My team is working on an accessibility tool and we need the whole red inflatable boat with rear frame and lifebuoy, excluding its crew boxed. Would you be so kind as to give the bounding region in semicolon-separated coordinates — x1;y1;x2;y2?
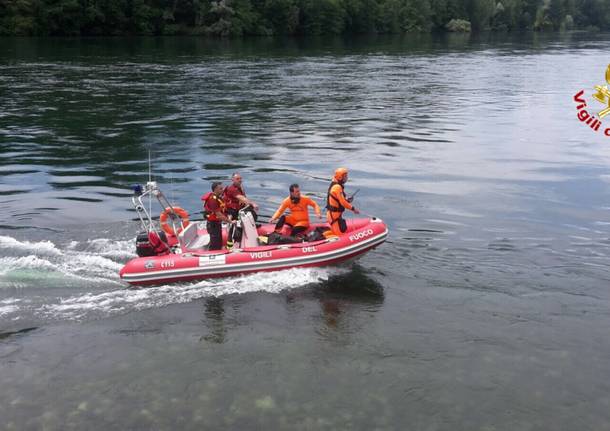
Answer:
120;183;388;285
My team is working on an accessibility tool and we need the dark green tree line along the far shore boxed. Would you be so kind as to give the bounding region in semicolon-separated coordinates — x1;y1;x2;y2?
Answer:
0;0;610;37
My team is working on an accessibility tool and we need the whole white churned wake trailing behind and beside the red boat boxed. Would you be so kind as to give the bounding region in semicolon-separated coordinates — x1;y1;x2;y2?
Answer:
0;236;332;321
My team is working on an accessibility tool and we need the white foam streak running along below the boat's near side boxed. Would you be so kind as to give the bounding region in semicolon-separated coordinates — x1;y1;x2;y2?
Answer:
39;268;330;320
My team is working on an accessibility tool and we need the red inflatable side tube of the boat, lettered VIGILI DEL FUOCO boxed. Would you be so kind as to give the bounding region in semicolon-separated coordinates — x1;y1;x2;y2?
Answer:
120;219;388;285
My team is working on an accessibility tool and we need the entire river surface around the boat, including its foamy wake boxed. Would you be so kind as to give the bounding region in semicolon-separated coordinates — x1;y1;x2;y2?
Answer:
0;33;610;431
